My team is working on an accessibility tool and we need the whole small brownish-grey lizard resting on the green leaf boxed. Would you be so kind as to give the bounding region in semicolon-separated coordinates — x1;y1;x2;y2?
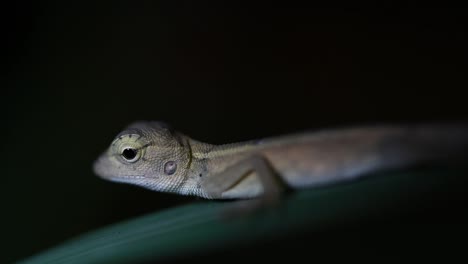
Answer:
93;121;468;204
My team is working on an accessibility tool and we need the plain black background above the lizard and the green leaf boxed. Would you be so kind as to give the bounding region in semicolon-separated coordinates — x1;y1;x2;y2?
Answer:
0;1;468;263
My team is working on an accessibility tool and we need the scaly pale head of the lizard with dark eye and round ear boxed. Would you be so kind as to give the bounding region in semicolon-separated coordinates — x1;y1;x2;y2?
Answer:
94;122;192;192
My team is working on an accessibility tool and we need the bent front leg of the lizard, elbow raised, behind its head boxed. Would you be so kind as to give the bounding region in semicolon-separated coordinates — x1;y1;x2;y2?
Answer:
201;154;286;204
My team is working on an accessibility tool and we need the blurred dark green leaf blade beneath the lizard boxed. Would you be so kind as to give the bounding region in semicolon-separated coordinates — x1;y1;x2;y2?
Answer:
17;170;466;263
